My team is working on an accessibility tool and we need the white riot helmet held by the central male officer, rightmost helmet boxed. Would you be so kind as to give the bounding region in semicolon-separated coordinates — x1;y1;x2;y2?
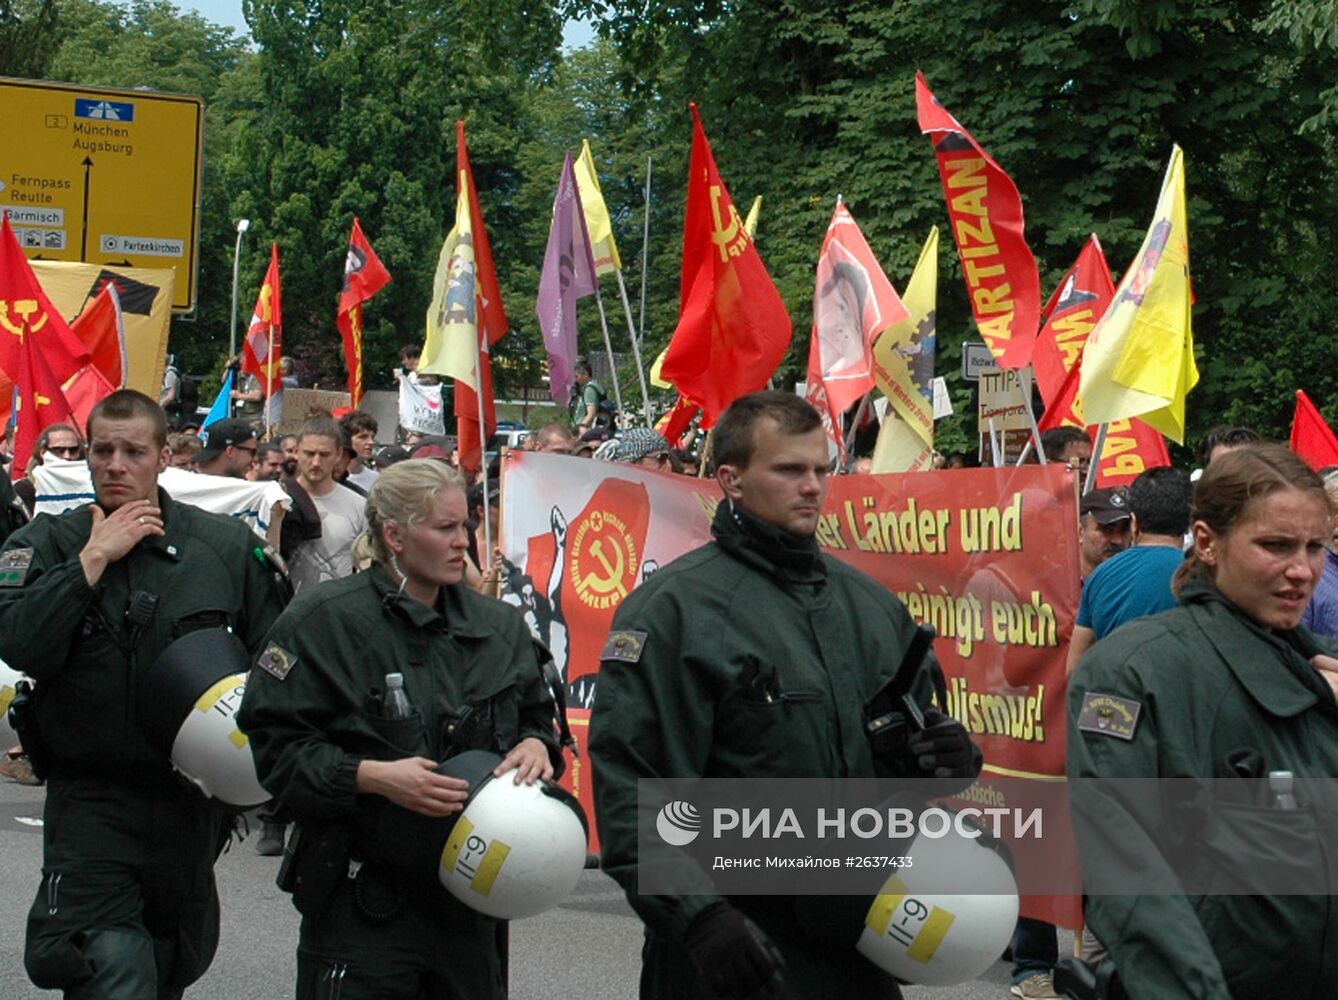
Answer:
855;825;1018;987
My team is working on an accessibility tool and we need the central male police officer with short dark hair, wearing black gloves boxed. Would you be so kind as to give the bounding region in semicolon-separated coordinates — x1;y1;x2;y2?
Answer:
590;392;981;1000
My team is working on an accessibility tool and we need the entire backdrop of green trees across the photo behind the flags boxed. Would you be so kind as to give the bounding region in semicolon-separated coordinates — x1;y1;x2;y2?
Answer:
10;0;1338;448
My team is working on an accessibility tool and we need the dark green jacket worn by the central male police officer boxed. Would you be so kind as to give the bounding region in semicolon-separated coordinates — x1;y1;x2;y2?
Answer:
590;503;914;968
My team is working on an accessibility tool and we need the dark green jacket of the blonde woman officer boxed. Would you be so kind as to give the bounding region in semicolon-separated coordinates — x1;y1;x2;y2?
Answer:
238;566;561;825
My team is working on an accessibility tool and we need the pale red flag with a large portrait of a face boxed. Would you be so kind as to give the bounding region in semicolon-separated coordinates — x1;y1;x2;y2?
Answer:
807;202;910;448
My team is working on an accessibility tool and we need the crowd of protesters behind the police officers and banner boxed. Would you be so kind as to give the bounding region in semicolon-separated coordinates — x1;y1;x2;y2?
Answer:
0;350;1338;1000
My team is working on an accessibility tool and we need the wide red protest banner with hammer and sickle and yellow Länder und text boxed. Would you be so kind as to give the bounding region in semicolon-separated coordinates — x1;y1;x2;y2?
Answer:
500;451;1078;926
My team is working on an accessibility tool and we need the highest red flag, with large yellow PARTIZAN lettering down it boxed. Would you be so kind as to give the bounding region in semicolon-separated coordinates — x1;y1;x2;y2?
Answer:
915;72;1041;368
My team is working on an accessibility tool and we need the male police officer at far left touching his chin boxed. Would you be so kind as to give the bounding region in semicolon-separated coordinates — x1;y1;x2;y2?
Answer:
0;390;282;1000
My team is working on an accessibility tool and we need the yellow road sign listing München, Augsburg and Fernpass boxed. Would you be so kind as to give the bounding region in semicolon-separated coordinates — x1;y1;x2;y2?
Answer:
0;79;205;312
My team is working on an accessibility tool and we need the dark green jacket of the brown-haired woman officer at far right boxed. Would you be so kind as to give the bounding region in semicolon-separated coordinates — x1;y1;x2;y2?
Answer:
1068;581;1338;1000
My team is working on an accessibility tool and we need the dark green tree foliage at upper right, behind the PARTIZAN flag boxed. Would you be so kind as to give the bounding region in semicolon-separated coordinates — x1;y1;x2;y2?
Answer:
574;0;1338;449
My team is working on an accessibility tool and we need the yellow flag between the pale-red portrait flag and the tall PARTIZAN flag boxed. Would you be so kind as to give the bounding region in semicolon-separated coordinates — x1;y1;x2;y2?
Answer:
874;226;938;473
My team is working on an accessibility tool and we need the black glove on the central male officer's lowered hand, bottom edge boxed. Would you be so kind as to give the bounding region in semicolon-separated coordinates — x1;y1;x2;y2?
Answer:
684;902;785;1000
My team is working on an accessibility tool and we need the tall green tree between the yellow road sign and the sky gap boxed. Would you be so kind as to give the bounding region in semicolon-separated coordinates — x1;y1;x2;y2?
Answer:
229;0;561;396
